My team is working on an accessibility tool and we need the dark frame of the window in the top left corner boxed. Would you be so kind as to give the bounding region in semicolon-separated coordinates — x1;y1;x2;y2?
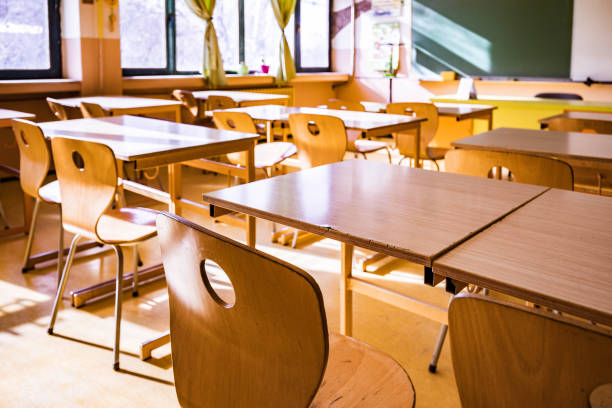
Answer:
0;0;62;80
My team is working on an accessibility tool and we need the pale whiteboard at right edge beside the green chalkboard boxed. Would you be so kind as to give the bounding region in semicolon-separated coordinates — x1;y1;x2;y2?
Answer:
570;0;612;81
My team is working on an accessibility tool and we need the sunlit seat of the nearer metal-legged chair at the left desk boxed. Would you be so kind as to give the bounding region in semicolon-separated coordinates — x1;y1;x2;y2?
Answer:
97;208;157;244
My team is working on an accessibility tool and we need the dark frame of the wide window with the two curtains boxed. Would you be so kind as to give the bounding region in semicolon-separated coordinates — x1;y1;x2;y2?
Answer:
123;0;333;77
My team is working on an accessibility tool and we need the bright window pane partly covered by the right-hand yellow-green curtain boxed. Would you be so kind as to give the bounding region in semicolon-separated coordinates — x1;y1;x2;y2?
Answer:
244;0;295;75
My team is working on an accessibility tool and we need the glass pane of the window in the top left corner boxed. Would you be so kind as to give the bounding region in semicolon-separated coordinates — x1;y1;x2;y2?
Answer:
0;0;51;70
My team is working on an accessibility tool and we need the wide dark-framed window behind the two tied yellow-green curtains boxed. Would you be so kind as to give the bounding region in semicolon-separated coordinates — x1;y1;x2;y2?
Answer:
120;0;331;76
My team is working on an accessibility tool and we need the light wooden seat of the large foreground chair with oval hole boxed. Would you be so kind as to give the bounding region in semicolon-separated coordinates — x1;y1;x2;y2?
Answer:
310;334;414;408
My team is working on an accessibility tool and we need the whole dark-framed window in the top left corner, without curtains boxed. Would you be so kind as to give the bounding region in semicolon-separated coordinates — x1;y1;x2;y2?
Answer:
0;0;62;79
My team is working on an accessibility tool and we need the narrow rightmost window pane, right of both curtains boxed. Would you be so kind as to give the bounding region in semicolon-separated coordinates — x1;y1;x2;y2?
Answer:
300;0;329;68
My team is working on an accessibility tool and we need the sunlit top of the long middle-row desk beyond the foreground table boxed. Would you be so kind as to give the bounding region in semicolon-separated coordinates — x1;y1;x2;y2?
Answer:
216;105;427;131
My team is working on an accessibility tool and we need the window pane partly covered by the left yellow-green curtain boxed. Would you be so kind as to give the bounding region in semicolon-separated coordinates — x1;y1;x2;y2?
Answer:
176;0;239;72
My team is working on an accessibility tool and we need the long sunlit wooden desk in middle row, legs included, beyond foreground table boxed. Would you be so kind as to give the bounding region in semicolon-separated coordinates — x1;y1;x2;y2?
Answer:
218;105;426;167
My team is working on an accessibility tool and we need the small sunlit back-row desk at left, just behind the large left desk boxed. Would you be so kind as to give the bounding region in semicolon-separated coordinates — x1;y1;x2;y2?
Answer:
57;95;182;122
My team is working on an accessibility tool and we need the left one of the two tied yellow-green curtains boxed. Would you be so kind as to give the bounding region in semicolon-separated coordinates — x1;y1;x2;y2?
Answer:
185;0;226;89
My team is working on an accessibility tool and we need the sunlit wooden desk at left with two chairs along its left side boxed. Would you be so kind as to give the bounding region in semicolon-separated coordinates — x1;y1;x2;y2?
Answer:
39;116;257;306
